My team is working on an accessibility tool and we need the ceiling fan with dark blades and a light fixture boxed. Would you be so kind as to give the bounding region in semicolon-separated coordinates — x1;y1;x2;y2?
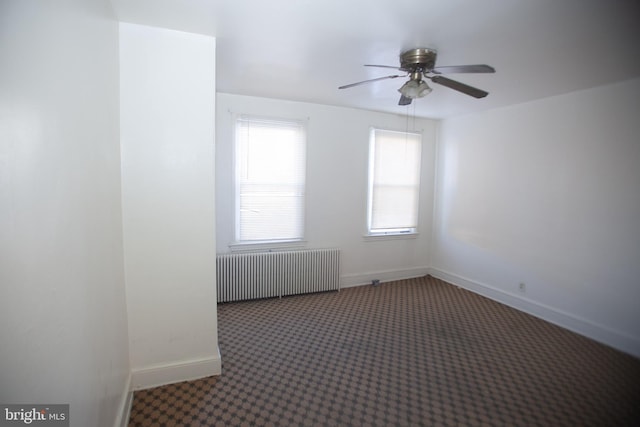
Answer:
338;48;496;105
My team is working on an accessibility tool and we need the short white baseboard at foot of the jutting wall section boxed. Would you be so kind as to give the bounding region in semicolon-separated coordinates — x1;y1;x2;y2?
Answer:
131;349;222;390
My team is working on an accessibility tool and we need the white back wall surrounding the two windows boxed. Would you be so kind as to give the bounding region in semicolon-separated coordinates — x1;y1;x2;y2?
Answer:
216;93;437;286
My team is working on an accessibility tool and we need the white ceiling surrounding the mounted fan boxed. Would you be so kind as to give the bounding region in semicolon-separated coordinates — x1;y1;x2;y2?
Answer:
112;0;640;118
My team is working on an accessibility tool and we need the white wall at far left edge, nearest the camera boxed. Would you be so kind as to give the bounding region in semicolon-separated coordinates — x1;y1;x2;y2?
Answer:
0;0;129;426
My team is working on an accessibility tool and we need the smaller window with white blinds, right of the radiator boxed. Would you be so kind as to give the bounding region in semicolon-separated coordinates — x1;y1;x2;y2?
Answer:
367;129;422;235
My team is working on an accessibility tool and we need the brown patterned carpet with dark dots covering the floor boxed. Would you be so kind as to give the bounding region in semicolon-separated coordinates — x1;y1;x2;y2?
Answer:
129;276;640;427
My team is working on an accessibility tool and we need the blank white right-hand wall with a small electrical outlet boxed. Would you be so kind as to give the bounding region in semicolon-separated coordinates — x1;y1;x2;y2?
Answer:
433;79;640;356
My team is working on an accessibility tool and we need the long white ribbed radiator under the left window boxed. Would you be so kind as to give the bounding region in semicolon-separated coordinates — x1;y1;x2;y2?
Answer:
216;249;340;302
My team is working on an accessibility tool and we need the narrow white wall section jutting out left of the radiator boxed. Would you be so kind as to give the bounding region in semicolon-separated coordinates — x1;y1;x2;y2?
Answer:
120;23;220;388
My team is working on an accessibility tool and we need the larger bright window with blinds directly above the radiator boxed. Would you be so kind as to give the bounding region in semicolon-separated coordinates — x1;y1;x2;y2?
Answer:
235;116;306;243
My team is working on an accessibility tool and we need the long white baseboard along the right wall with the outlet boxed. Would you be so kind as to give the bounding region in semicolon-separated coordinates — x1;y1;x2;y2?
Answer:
428;268;640;357
